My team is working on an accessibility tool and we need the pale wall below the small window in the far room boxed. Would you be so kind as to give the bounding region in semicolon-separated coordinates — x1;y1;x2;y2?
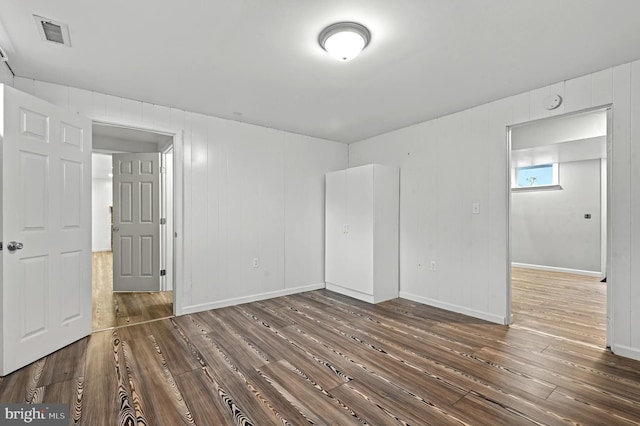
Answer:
511;159;601;273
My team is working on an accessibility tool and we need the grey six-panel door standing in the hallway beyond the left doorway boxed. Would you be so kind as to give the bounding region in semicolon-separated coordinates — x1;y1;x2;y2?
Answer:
113;152;161;291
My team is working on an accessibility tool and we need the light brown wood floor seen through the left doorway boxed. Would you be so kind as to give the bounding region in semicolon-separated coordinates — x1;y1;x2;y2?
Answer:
92;252;173;331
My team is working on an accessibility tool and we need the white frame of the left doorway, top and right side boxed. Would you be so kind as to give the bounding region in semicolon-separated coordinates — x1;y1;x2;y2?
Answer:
91;120;184;316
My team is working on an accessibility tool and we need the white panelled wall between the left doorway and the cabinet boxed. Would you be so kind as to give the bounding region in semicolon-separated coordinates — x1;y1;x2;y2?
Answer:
7;77;348;314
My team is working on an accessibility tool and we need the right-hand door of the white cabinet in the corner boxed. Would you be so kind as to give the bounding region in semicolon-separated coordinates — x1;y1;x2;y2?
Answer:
346;166;374;294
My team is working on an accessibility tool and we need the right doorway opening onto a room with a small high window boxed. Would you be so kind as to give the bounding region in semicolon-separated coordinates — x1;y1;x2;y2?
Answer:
507;107;611;347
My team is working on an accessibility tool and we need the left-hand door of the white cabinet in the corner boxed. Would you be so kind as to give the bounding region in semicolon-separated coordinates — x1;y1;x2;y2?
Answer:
324;170;348;286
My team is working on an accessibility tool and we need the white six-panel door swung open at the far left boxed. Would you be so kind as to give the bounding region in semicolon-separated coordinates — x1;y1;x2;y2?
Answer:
0;85;91;376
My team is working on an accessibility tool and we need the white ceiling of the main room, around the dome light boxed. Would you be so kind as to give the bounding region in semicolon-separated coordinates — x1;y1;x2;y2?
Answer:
0;0;640;143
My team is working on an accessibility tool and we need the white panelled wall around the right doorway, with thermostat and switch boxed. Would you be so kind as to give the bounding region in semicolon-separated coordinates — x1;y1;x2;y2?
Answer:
349;61;640;359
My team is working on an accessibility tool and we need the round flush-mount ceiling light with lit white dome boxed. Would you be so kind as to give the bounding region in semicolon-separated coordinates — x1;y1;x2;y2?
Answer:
318;22;371;61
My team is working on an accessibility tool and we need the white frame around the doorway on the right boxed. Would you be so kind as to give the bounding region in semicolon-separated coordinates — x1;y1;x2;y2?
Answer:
505;104;614;348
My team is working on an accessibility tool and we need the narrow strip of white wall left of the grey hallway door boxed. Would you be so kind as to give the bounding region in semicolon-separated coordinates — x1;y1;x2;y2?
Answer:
91;153;113;252
